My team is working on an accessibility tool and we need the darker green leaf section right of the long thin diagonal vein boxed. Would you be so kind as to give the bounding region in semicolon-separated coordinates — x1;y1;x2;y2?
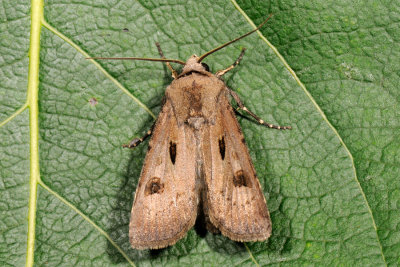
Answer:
239;0;400;266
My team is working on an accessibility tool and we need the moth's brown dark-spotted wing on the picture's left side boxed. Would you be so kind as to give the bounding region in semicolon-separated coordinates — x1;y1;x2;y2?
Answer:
129;97;198;249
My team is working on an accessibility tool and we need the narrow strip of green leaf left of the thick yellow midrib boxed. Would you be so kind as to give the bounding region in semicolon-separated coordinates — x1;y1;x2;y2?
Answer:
0;1;30;266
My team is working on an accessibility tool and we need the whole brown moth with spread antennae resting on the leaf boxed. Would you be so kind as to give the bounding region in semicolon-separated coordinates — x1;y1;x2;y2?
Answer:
93;14;291;249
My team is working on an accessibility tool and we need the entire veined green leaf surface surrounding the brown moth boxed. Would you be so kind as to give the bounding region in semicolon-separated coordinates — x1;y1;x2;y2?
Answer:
0;0;400;266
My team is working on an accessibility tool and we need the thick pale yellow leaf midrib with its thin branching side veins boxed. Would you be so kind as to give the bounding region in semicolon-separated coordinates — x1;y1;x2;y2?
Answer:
22;0;142;267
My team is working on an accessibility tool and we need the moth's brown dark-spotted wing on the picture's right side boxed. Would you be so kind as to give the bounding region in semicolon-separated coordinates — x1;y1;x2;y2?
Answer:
202;89;271;242
